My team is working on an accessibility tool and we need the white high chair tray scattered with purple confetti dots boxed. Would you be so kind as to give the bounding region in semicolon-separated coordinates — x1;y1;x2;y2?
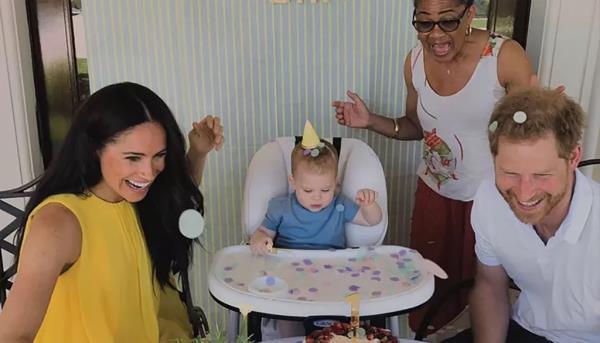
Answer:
208;246;434;317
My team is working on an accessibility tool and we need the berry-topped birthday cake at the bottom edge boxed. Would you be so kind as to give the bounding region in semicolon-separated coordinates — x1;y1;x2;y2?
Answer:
304;322;398;343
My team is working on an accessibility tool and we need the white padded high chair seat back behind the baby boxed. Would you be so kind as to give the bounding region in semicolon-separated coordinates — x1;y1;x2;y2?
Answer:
228;137;388;338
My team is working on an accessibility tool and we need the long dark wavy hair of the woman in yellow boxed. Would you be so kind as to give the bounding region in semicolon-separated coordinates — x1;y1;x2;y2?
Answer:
15;82;204;287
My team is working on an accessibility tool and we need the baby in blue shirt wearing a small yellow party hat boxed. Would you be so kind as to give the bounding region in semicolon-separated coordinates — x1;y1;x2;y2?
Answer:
250;121;382;255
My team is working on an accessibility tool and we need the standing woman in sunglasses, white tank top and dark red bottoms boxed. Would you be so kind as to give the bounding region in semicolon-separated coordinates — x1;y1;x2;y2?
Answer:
333;0;532;329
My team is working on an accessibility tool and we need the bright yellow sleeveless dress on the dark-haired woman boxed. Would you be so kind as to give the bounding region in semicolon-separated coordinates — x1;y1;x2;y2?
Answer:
25;194;160;343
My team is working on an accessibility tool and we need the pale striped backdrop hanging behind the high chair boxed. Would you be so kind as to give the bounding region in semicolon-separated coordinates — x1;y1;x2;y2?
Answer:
83;0;421;334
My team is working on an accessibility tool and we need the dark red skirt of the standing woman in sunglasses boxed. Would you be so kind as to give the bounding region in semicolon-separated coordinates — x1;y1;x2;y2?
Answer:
409;179;476;331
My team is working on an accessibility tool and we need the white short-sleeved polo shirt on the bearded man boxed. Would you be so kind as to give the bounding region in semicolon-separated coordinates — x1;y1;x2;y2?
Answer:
471;171;600;343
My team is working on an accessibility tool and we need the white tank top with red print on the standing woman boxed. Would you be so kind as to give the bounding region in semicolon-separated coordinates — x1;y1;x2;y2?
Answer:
411;34;506;201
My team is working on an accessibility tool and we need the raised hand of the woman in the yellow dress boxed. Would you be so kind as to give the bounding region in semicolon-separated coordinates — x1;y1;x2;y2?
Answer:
188;115;224;156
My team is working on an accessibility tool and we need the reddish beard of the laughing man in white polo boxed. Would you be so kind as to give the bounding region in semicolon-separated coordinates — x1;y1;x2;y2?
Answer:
500;188;567;225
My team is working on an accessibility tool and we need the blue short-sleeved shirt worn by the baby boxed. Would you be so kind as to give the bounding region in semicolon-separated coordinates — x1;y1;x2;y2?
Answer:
262;192;358;249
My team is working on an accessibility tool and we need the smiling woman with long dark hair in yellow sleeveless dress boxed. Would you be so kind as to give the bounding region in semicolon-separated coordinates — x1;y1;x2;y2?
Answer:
0;83;223;343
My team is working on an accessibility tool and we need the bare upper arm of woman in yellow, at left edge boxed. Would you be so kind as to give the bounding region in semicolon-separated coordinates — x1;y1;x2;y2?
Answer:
0;203;81;342
